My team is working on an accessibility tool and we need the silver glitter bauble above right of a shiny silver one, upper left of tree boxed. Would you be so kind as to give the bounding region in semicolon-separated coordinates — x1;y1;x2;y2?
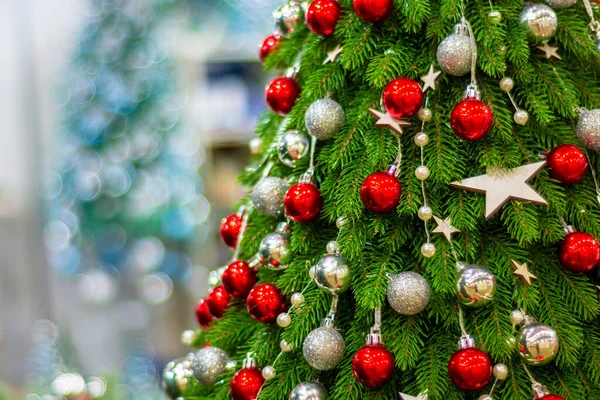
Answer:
304;99;346;140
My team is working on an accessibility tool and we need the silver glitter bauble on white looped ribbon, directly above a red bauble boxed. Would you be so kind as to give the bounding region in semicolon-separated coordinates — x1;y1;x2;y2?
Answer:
437;24;473;76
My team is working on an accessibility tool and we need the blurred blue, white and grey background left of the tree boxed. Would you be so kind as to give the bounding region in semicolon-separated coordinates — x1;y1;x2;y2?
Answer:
0;0;281;400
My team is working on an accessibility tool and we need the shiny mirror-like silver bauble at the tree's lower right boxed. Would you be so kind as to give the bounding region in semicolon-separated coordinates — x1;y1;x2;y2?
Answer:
517;322;559;365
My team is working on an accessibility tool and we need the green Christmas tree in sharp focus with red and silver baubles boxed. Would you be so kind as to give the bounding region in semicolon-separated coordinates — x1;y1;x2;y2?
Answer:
165;0;600;400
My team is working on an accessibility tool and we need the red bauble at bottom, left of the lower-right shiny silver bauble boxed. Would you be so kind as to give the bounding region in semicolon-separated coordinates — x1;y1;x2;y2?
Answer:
448;348;492;390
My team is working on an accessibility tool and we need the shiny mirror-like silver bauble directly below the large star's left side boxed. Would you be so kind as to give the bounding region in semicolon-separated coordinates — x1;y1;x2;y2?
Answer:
456;265;496;307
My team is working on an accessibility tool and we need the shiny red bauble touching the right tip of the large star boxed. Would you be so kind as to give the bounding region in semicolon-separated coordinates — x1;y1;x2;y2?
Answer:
546;144;587;185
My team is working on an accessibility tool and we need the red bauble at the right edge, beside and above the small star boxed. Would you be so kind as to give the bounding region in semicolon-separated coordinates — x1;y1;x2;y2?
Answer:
558;232;600;274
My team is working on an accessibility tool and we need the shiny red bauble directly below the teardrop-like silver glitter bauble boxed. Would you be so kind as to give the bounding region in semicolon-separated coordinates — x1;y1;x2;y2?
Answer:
450;98;493;141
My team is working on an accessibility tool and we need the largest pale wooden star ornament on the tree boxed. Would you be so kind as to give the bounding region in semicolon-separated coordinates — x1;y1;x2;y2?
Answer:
450;161;548;219
